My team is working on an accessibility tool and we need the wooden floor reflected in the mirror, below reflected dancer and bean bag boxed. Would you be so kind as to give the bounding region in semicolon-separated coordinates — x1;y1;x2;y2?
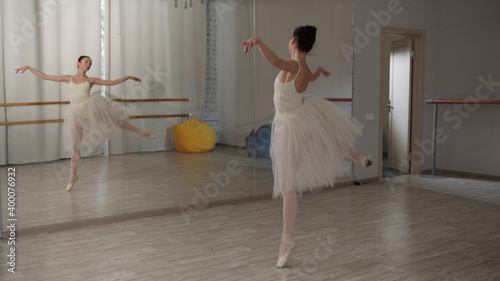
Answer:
0;146;351;233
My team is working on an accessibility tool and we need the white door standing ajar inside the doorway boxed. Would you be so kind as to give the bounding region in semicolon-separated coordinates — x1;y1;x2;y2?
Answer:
388;38;413;173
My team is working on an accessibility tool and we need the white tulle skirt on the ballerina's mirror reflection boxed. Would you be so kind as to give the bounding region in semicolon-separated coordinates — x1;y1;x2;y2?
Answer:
64;94;130;155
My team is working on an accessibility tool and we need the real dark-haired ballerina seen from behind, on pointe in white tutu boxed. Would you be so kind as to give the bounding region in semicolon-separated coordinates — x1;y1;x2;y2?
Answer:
241;26;372;268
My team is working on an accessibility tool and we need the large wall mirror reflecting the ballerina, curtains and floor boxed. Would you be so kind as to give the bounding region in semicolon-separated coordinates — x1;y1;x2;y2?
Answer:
0;0;353;231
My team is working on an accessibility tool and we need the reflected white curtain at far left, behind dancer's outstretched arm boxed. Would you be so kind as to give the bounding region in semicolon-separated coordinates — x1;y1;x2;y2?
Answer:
0;0;100;164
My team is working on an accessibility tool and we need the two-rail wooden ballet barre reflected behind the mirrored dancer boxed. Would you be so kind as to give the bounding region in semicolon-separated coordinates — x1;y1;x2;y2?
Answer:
0;98;193;126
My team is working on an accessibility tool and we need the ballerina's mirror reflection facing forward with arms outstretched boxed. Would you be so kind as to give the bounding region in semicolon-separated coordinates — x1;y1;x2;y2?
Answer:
15;56;155;191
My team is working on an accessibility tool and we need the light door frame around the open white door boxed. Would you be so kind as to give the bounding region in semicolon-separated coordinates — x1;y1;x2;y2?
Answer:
378;26;425;180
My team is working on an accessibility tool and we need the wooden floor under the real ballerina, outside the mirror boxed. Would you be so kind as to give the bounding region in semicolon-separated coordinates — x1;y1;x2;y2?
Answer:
0;153;500;281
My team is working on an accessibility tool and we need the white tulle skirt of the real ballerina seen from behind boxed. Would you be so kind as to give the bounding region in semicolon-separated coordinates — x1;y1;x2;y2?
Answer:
270;95;362;198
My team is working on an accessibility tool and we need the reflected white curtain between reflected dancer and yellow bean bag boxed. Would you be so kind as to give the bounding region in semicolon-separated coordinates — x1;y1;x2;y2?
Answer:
109;0;206;154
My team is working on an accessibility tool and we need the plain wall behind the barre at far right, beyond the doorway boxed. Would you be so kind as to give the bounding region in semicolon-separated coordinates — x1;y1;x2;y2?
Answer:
432;0;500;176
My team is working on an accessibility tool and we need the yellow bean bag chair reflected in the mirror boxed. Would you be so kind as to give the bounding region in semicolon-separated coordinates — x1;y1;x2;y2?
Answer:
174;119;216;152
